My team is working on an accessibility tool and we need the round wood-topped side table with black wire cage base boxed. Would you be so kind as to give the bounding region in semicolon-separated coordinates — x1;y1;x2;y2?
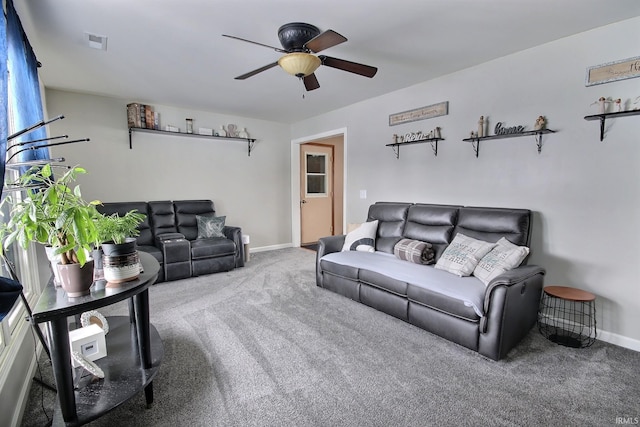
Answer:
538;286;597;348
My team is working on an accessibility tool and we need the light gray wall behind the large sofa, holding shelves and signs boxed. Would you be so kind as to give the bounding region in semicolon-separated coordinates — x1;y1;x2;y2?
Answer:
292;18;640;350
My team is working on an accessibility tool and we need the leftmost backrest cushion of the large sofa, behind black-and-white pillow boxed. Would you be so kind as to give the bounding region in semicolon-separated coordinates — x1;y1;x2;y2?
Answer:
367;202;411;254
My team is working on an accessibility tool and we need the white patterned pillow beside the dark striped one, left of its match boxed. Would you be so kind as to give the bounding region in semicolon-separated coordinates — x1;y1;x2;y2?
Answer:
435;233;496;277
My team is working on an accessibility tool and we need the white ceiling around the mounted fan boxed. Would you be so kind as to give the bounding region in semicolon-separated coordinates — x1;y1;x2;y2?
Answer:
15;0;640;123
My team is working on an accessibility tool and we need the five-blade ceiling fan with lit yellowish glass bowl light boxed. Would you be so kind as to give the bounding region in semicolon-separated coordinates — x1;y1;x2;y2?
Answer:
223;22;378;91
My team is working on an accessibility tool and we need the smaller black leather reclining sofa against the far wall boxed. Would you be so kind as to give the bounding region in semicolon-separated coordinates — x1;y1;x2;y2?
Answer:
98;200;244;282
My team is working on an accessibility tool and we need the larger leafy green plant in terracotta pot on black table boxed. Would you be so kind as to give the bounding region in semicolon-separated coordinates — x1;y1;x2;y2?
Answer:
1;165;100;297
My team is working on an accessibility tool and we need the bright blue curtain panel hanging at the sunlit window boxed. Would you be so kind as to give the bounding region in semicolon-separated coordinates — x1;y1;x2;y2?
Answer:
5;0;49;167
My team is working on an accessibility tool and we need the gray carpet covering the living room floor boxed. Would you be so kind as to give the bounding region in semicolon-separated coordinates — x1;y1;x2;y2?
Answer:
23;248;640;426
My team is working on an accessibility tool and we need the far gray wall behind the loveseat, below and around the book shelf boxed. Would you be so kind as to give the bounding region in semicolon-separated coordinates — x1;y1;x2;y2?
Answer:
46;89;291;248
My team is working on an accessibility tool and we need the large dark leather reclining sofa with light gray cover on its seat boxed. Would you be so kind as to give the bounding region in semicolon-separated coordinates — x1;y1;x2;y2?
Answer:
316;202;545;360
